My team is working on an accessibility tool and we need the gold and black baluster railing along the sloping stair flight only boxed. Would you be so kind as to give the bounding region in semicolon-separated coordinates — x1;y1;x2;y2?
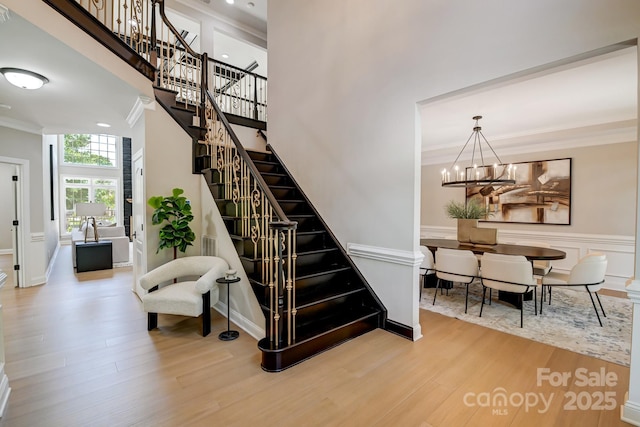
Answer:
205;92;297;348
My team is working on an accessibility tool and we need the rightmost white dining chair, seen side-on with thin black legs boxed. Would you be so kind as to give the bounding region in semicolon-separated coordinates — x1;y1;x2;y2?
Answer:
540;252;607;326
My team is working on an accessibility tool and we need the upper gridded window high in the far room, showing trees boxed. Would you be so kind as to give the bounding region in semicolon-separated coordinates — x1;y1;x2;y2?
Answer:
62;134;118;168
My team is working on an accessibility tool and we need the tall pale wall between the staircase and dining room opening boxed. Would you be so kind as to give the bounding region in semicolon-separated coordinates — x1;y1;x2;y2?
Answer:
268;0;640;328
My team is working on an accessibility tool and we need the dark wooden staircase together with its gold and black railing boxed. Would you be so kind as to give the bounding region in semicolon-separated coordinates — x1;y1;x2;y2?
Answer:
45;0;389;372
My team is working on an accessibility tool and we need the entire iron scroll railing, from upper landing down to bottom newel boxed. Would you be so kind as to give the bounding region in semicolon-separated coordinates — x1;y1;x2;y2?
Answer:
60;0;290;348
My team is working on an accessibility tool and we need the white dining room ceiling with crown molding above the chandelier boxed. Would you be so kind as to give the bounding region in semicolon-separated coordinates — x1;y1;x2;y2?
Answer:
419;46;638;164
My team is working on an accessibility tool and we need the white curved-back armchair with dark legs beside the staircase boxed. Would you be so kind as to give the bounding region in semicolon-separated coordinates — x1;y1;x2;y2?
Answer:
140;256;229;337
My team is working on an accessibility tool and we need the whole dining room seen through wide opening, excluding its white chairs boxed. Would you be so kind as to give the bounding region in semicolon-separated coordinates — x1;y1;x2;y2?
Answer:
419;45;638;378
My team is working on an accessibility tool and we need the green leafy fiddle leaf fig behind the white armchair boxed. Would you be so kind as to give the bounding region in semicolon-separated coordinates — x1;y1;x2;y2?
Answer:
147;188;196;259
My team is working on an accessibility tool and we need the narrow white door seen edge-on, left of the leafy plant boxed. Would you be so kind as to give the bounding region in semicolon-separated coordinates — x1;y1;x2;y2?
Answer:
131;150;147;298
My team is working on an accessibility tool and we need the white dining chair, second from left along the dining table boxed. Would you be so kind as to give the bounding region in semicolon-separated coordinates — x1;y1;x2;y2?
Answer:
433;248;479;313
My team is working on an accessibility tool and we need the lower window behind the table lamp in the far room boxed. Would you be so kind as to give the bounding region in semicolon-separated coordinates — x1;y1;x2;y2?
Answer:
62;176;119;233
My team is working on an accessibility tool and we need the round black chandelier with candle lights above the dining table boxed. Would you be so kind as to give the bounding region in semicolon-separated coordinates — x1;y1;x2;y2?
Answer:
442;116;516;187
